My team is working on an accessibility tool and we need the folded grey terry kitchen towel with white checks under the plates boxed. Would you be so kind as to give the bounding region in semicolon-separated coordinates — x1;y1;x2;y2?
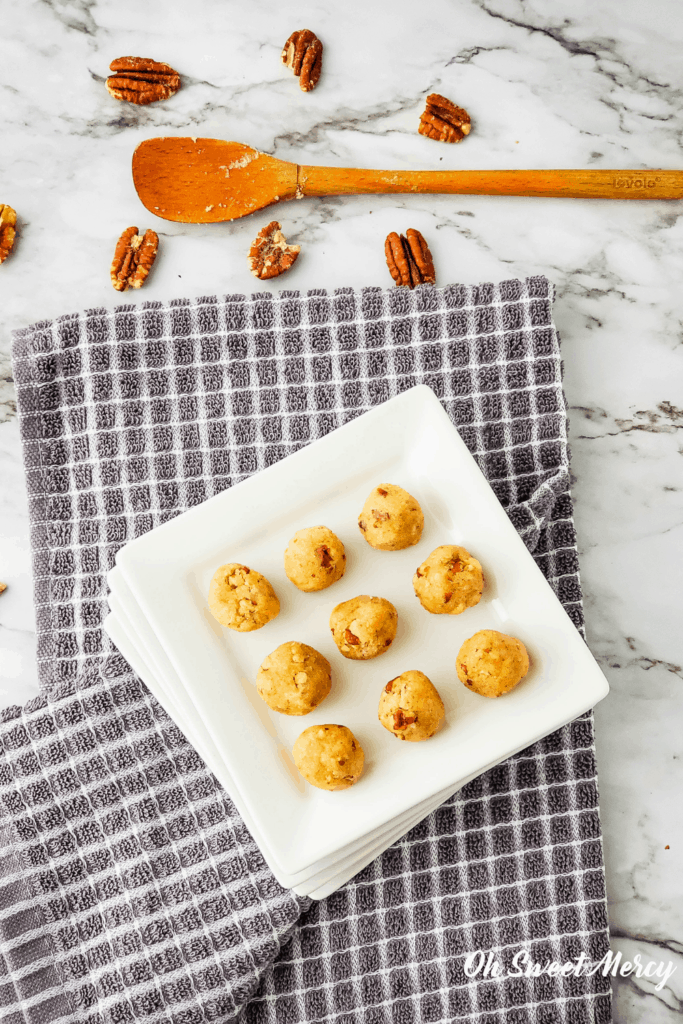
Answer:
0;278;610;1024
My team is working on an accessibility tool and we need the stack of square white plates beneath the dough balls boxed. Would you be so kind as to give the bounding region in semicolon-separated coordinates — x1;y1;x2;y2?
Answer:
104;386;607;899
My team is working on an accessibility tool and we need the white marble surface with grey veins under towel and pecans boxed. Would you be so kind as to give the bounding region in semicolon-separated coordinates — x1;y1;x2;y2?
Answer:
0;0;683;1024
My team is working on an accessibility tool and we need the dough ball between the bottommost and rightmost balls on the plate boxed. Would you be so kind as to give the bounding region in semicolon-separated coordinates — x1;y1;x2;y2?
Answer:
379;671;445;743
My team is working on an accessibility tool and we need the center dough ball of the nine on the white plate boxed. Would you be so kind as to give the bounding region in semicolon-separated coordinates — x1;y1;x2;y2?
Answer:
330;594;398;662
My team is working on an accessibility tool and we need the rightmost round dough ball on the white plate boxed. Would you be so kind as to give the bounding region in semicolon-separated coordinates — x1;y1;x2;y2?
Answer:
456;630;528;697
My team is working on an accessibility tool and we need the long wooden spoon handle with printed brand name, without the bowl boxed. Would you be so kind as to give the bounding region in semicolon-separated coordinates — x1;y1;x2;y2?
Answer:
297;167;683;199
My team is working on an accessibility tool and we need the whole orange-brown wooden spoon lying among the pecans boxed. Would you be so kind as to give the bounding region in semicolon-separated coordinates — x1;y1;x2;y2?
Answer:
133;138;683;224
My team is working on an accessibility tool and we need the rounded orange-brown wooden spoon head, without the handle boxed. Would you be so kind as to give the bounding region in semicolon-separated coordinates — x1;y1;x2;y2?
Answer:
133;136;297;224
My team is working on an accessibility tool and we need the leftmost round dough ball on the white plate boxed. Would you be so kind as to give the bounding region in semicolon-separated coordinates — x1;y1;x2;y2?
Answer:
209;562;280;633
